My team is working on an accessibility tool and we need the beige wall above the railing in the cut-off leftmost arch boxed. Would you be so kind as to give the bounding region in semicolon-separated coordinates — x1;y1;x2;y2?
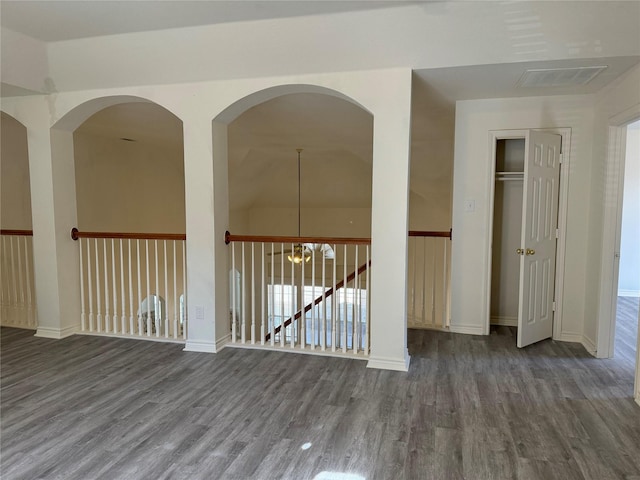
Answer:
0;113;31;230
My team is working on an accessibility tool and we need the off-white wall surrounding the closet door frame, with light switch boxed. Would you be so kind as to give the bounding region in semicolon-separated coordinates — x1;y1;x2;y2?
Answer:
451;96;593;341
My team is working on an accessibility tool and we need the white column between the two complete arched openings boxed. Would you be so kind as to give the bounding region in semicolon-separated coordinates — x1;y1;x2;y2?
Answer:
182;113;229;353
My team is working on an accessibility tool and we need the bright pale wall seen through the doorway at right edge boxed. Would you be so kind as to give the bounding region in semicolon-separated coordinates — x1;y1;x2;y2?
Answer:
618;121;640;297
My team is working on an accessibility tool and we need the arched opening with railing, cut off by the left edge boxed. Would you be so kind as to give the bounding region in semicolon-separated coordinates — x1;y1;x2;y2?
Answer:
0;112;37;329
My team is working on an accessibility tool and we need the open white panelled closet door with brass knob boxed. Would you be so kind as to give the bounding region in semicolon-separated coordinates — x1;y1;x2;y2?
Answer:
518;131;562;347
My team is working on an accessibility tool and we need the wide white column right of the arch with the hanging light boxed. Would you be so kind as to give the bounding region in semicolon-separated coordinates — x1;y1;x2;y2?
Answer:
367;73;411;371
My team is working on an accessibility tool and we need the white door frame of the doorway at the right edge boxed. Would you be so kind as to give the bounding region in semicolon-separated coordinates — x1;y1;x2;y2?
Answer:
595;103;640;360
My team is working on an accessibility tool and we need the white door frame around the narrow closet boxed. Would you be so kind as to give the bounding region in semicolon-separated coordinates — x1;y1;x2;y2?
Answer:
482;127;582;341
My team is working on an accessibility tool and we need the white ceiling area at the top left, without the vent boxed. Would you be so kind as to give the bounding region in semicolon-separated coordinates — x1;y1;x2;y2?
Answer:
0;0;424;42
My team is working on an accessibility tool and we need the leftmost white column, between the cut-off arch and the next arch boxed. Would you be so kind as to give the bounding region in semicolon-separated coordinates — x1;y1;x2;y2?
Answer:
27;122;80;338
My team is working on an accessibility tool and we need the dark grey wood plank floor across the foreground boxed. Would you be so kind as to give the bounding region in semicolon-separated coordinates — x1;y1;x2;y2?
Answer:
1;300;640;480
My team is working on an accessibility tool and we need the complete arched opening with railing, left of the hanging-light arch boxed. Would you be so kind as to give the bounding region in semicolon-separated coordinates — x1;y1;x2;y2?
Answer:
52;97;186;340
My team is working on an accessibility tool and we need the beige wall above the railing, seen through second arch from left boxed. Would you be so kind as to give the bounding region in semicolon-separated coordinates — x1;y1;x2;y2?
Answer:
73;131;185;233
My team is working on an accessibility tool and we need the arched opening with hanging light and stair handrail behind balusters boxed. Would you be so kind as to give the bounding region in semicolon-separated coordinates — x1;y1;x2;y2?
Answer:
214;88;373;353
